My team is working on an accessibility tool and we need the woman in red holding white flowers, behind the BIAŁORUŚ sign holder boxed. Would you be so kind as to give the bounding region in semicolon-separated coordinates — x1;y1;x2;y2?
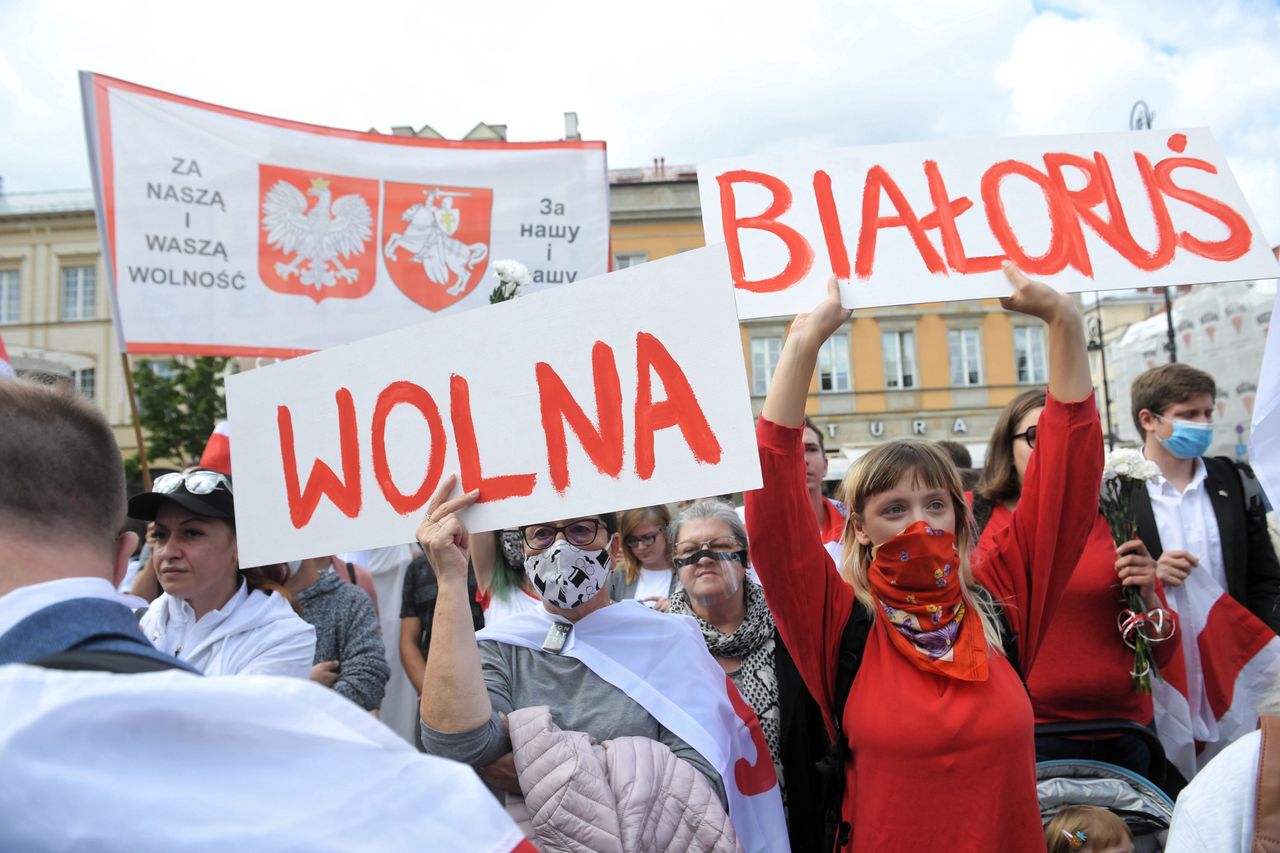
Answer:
973;389;1176;776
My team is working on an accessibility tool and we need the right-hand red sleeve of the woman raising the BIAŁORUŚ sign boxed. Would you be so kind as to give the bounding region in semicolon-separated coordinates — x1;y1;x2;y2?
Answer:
973;394;1102;672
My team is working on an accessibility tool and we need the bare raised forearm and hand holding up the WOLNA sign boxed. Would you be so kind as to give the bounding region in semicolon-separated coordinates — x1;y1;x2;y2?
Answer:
417;475;493;733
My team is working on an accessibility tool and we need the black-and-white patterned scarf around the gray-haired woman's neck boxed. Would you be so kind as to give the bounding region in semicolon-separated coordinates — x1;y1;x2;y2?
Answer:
671;578;782;783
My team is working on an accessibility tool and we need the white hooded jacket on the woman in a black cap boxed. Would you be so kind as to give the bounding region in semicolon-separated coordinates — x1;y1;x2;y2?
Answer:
141;583;316;679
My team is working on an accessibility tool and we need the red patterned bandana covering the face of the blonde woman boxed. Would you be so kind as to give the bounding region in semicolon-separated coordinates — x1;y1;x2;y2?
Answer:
868;521;987;681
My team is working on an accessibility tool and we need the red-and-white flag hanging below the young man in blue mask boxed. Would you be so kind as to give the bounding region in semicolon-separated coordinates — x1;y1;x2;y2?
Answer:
1152;570;1280;779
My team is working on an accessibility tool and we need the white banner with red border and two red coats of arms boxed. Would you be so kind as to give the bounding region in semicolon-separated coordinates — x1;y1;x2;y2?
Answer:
81;73;609;356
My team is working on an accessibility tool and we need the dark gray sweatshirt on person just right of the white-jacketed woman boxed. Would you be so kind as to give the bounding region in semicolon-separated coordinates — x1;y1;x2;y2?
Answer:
297;569;390;711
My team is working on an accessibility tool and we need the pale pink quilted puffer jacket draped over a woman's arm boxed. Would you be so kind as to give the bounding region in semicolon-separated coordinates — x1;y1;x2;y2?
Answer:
508;706;739;853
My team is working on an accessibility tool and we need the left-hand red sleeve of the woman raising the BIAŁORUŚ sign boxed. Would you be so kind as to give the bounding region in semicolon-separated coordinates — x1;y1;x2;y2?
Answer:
744;418;854;733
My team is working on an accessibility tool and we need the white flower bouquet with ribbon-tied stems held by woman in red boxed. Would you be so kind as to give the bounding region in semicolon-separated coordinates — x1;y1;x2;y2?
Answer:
1100;450;1167;693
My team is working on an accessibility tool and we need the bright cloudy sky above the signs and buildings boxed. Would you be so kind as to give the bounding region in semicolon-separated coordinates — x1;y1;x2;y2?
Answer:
0;0;1280;243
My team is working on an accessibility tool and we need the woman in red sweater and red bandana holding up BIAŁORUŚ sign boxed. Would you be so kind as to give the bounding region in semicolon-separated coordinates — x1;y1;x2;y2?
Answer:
746;266;1102;850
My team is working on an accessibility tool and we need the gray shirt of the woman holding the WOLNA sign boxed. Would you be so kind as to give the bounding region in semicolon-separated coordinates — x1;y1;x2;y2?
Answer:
420;640;724;803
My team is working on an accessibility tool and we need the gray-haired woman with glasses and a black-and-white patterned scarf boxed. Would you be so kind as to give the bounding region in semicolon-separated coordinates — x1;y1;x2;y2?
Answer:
668;498;827;850
